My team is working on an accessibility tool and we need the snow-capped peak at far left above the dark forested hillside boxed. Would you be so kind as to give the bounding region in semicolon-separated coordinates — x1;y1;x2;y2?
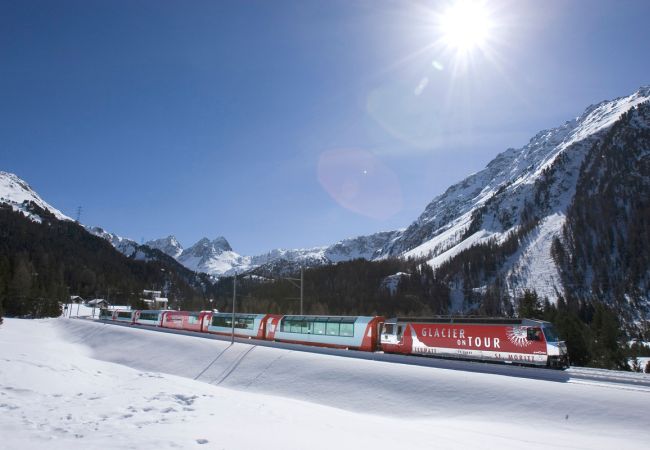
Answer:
0;171;72;222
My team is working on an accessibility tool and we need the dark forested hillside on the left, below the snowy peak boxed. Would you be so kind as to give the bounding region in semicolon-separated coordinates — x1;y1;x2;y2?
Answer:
0;202;208;317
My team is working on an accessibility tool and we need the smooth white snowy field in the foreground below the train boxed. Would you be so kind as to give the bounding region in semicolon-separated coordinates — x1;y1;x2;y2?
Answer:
0;319;650;450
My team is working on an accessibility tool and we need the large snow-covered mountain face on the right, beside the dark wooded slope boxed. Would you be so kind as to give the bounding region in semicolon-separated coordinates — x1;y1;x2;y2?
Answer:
374;87;650;306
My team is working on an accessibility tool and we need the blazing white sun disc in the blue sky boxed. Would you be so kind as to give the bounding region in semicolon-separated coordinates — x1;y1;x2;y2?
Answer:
439;0;492;53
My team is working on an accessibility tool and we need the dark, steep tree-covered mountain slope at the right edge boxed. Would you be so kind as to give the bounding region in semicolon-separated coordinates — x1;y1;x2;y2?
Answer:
553;103;650;320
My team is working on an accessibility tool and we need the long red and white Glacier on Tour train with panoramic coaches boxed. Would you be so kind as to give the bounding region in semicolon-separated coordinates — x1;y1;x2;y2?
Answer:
99;309;569;369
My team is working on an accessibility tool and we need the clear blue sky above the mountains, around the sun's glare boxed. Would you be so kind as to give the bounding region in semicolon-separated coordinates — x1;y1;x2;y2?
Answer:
0;0;650;254
